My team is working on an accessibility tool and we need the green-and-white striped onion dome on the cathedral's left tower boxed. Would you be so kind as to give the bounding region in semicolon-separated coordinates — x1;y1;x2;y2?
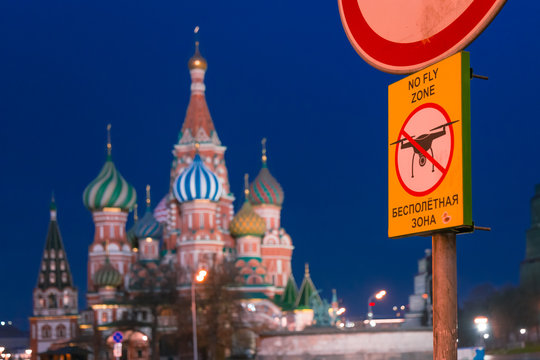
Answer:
83;155;137;210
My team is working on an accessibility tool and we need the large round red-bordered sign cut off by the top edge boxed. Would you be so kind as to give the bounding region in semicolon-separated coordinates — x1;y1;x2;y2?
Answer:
338;0;506;74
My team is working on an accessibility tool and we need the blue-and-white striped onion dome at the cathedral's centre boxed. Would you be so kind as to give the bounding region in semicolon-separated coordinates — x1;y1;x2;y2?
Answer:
173;154;223;203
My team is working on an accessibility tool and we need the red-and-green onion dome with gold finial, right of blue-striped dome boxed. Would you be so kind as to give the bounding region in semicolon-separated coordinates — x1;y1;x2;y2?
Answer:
249;139;284;206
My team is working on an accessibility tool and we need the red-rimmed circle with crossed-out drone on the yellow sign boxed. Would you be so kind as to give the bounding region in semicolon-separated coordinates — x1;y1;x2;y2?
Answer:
393;103;457;196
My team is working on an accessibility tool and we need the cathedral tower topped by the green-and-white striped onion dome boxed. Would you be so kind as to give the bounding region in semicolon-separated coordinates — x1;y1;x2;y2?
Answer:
83;125;137;305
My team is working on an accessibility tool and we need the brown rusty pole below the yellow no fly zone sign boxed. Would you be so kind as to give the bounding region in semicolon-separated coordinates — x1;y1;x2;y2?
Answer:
433;232;457;360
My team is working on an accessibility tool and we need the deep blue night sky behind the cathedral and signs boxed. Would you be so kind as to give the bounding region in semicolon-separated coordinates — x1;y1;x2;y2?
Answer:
0;0;540;327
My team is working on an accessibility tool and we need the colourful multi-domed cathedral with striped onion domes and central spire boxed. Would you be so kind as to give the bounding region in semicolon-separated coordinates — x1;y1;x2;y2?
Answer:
30;35;321;359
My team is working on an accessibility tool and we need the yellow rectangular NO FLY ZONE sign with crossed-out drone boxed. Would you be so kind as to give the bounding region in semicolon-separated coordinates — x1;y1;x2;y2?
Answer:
388;52;473;238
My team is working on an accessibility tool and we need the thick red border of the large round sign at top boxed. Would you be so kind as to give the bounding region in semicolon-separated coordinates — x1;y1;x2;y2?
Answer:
338;0;506;74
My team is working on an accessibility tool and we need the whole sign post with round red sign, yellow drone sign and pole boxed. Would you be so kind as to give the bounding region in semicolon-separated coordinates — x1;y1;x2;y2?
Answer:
338;0;506;360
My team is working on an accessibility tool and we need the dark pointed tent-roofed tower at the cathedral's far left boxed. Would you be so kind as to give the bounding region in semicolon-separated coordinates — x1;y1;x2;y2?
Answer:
30;197;78;359
